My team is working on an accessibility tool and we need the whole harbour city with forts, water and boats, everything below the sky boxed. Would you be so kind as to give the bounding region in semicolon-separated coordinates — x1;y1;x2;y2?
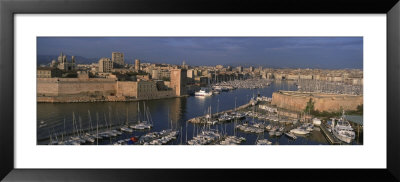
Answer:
37;38;363;145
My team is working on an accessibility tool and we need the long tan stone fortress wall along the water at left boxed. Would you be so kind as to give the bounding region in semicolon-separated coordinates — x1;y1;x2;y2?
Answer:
37;78;180;102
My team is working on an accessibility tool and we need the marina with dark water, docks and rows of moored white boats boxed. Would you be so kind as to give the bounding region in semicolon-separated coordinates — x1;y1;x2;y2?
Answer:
37;81;362;145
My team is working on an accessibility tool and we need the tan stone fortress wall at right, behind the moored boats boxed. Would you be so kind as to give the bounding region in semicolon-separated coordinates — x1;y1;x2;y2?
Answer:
272;92;363;112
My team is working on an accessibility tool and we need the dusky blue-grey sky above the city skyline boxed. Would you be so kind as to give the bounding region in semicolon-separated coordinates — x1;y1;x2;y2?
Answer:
37;37;363;69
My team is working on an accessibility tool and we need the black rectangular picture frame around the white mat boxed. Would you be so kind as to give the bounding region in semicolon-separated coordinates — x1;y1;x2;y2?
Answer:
0;0;400;181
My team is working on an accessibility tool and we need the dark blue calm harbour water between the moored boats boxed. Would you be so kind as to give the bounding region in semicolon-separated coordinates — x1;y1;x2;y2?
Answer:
37;81;327;145
